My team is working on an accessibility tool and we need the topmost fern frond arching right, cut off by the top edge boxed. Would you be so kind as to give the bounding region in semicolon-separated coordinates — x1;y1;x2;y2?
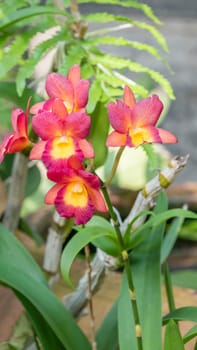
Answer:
78;0;161;24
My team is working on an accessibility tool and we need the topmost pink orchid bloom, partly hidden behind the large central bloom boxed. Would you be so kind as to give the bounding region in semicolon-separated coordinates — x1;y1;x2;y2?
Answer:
30;65;89;117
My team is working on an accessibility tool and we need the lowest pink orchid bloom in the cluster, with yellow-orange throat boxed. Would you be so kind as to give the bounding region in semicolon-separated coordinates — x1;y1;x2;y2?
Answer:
45;159;107;225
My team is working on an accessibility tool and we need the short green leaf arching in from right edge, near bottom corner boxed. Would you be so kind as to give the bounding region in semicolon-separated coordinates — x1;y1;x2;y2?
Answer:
163;306;197;324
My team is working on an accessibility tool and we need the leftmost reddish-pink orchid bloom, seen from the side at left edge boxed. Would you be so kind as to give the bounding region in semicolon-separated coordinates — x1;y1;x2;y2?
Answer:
0;108;31;163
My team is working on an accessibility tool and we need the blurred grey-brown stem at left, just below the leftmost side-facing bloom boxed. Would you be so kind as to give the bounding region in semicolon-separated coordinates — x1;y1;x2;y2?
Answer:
3;153;28;232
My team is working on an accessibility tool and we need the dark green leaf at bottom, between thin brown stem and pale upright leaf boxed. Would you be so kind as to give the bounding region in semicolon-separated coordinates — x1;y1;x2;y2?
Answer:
96;300;118;350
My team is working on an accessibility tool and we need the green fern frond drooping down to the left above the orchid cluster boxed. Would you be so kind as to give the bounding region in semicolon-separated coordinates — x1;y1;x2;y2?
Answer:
16;30;66;96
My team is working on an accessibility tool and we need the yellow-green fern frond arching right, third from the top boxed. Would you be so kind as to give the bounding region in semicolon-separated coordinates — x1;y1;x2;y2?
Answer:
86;36;164;61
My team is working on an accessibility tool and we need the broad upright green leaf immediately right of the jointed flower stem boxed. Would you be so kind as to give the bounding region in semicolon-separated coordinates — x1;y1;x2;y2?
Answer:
131;193;167;350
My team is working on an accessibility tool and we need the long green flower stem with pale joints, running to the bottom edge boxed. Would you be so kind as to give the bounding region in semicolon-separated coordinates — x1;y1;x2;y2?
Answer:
102;185;143;350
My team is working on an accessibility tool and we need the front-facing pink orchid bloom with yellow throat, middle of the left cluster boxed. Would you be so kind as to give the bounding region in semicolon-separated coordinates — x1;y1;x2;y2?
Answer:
30;112;94;171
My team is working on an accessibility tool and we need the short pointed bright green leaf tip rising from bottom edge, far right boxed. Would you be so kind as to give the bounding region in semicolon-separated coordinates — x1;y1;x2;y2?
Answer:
164;320;184;350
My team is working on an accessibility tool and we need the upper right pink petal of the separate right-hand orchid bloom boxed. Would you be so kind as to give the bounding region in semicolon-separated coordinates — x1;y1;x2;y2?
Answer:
132;95;163;128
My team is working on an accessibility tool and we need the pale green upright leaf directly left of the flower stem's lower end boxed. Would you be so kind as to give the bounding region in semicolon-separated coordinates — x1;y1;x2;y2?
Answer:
118;274;138;350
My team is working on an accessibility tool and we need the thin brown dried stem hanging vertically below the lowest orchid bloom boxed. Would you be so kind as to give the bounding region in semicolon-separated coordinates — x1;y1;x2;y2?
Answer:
85;245;97;350
